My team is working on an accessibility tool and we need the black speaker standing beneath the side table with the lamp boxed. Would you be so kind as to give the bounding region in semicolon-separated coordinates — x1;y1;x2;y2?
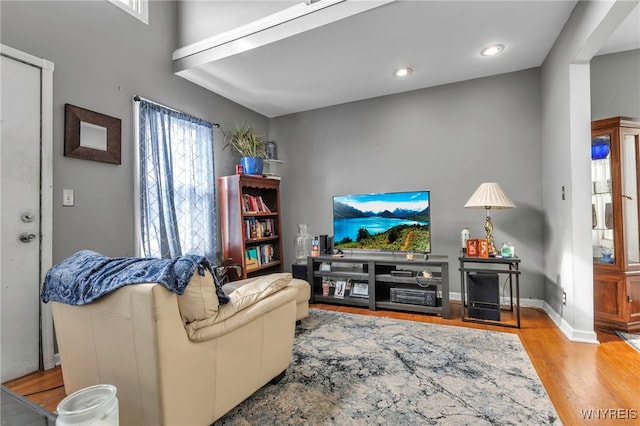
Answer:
467;272;500;321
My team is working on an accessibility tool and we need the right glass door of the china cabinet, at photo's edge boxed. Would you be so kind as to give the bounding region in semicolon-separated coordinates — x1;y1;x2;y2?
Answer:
620;128;640;270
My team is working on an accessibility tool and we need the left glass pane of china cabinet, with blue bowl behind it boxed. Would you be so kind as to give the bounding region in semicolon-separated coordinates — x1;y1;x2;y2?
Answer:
591;133;615;264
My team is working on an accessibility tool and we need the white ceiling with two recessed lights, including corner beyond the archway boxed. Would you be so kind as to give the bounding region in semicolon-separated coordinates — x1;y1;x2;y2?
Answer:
174;0;640;117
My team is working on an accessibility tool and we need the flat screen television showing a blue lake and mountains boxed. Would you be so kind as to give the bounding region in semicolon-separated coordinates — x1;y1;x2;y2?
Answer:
333;190;431;253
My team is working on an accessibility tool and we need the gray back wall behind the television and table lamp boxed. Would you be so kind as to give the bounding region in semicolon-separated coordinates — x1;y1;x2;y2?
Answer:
270;69;544;299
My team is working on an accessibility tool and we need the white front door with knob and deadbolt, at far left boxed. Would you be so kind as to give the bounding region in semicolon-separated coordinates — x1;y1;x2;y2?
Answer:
0;46;53;382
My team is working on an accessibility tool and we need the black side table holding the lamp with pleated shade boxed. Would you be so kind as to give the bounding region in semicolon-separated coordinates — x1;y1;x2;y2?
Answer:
458;256;520;328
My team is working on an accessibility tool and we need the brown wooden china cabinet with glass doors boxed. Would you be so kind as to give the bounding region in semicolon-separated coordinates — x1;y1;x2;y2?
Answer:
591;117;640;332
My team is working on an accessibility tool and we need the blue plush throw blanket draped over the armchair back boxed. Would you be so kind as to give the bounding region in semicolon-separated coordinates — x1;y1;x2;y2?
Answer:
41;250;229;305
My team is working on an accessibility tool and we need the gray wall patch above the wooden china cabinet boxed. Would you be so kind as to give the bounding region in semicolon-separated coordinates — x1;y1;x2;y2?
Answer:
591;49;640;120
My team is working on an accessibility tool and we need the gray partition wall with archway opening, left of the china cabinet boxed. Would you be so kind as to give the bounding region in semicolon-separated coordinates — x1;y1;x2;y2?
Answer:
541;1;636;342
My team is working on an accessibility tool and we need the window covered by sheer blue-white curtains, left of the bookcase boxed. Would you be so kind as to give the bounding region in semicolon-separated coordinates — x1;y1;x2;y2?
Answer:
134;100;217;263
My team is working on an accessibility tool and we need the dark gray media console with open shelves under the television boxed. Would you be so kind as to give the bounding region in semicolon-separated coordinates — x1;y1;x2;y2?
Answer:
307;253;450;318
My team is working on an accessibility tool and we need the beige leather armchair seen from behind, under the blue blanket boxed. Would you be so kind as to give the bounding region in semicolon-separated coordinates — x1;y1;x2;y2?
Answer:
52;271;308;425
